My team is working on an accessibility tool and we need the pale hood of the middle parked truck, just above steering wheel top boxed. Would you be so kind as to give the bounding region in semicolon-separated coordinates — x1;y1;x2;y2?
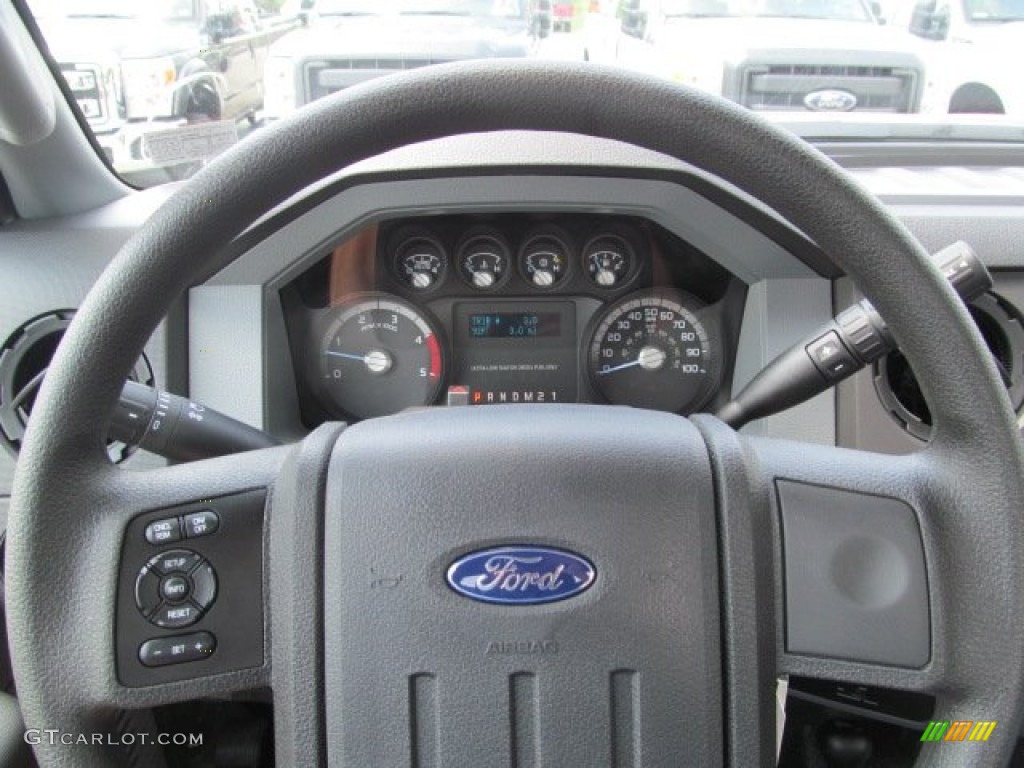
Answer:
270;15;530;59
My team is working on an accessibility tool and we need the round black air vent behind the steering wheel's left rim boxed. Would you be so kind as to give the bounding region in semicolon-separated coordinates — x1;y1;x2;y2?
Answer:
0;309;154;463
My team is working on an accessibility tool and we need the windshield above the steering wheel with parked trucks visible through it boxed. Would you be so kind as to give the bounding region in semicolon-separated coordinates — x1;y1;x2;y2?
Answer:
19;0;1024;186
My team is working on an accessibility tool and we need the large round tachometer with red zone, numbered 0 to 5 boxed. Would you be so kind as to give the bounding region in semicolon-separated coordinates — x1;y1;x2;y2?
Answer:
319;294;444;419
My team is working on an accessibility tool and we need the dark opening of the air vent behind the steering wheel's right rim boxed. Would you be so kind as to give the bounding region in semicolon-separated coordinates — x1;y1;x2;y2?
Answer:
874;294;1024;440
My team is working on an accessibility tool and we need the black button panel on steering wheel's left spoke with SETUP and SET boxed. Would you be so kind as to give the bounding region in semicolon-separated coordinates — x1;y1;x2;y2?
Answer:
115;490;266;687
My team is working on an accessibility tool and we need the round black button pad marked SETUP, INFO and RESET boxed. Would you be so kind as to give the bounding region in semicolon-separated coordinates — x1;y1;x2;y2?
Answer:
135;550;217;629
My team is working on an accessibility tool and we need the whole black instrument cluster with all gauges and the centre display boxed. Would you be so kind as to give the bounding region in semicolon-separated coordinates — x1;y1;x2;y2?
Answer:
282;213;745;426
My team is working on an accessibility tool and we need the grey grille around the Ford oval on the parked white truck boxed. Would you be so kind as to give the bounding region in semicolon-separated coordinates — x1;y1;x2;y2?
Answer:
740;65;918;112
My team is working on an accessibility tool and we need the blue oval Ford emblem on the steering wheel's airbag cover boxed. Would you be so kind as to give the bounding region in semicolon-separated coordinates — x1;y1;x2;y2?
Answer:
447;547;597;605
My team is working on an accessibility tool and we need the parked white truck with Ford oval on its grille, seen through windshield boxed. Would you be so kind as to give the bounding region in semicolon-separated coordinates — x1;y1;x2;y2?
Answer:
616;0;925;113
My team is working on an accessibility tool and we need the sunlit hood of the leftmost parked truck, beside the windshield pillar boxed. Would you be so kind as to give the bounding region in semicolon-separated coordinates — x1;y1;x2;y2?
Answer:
41;17;202;63
